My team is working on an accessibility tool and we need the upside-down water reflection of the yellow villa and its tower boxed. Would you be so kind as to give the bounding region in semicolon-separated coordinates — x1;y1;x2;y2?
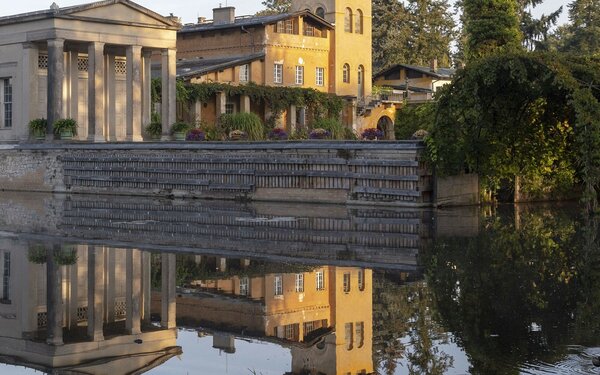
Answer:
156;256;373;375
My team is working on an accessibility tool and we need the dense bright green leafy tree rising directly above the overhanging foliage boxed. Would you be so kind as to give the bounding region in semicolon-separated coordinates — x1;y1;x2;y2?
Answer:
463;0;523;61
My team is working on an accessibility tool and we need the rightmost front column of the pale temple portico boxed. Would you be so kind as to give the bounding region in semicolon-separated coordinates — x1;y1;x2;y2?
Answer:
161;49;177;140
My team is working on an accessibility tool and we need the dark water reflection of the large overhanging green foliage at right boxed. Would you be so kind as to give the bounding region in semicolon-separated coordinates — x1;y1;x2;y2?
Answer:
425;210;600;374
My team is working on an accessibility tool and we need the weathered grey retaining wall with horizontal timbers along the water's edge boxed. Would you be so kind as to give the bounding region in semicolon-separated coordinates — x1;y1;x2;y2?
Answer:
0;142;432;206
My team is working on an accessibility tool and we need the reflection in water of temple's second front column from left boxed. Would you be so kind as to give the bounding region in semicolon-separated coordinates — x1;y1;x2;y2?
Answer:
87;246;104;341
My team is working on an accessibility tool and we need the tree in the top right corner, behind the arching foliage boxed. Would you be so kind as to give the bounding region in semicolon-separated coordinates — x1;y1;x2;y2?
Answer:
561;0;600;55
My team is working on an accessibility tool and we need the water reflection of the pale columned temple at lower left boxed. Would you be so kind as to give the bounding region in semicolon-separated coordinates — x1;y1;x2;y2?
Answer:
0;240;181;374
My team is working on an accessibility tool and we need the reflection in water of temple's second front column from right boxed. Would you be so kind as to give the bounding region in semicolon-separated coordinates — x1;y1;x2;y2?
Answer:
125;249;142;335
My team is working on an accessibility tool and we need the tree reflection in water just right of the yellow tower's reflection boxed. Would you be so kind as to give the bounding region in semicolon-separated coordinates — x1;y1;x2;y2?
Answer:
373;274;452;375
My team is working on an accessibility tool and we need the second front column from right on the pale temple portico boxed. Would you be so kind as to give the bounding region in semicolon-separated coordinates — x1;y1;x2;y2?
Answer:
126;46;142;142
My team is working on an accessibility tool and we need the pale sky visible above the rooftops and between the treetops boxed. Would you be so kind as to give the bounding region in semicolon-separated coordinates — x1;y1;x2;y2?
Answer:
0;0;570;23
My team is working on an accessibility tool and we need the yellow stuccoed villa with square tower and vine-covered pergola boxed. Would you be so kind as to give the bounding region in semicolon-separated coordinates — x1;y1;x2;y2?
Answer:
177;0;395;139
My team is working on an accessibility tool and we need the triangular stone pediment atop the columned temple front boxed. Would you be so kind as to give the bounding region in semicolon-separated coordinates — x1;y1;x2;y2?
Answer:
68;1;174;27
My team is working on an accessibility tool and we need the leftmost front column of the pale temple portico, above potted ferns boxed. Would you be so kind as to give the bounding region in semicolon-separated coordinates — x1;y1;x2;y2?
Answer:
47;39;65;135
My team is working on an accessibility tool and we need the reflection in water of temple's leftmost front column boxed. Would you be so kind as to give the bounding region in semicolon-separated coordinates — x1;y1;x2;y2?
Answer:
46;246;63;345
